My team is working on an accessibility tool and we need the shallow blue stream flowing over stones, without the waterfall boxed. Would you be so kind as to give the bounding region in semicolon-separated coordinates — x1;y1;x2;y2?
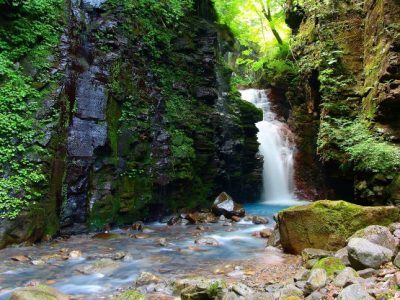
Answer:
0;204;296;300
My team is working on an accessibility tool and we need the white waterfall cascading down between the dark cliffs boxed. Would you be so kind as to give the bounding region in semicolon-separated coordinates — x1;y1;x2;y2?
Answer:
240;89;295;205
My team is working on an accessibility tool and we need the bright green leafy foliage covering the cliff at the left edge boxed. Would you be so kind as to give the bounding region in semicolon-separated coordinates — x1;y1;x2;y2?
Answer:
0;0;63;218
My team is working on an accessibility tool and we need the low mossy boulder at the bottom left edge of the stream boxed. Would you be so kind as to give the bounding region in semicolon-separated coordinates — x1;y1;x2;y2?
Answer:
10;284;70;300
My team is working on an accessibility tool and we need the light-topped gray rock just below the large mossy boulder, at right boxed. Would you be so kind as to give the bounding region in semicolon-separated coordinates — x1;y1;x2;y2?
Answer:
347;238;393;270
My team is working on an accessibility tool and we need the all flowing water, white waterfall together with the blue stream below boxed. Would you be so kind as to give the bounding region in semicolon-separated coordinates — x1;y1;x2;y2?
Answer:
0;90;300;299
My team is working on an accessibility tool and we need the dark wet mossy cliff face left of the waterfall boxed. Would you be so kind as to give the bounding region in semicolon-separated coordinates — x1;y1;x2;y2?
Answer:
0;1;262;246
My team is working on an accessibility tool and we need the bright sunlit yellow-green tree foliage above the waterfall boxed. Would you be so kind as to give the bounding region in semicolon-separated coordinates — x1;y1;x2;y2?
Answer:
214;0;293;83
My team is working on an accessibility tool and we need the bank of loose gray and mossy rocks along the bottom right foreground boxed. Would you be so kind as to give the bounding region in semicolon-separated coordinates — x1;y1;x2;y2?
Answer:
108;223;400;300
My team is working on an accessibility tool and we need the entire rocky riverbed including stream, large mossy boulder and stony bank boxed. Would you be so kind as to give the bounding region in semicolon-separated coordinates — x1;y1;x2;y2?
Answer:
0;200;400;300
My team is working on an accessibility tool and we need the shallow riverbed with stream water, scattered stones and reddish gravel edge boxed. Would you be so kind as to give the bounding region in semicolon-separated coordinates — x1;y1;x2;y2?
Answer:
0;203;301;299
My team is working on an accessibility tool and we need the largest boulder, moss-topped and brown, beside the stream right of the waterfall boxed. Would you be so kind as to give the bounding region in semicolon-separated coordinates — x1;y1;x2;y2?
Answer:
277;200;400;254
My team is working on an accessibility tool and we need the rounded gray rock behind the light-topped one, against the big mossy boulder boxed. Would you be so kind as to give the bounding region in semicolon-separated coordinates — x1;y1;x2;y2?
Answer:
350;225;397;252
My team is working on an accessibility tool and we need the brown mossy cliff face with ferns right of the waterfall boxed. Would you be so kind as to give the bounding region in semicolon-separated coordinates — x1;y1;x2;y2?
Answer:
287;0;400;204
